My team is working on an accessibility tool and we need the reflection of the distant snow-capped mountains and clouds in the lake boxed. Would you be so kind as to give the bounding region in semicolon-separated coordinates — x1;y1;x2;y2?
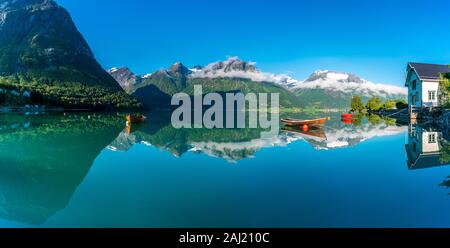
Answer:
108;113;407;162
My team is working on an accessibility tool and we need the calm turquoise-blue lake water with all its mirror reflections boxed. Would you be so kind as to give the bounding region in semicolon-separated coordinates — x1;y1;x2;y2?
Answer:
0;113;450;227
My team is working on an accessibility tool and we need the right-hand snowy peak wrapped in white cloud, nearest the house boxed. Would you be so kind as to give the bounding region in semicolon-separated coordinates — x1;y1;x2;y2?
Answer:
293;71;407;98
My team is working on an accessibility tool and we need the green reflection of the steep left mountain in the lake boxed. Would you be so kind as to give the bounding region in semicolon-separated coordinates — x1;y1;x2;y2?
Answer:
0;114;123;224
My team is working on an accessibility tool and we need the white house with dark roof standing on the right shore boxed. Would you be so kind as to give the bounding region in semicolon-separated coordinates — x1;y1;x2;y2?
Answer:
406;63;450;107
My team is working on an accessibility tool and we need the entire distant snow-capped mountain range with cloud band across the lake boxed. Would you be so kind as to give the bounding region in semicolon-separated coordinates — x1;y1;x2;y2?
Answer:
109;57;407;109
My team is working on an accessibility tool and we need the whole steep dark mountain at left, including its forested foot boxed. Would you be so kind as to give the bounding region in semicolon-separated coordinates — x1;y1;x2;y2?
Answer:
0;0;138;108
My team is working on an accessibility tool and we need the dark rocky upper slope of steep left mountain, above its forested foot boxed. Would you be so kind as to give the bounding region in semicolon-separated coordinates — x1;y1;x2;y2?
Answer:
0;0;96;74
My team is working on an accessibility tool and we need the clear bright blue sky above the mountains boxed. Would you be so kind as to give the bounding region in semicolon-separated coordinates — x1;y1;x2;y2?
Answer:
56;0;450;85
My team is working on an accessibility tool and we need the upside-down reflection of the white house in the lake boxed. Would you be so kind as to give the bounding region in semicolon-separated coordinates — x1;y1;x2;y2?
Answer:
406;125;448;170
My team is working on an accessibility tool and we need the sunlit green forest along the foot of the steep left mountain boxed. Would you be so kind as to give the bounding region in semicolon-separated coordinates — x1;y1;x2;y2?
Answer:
0;74;141;110
